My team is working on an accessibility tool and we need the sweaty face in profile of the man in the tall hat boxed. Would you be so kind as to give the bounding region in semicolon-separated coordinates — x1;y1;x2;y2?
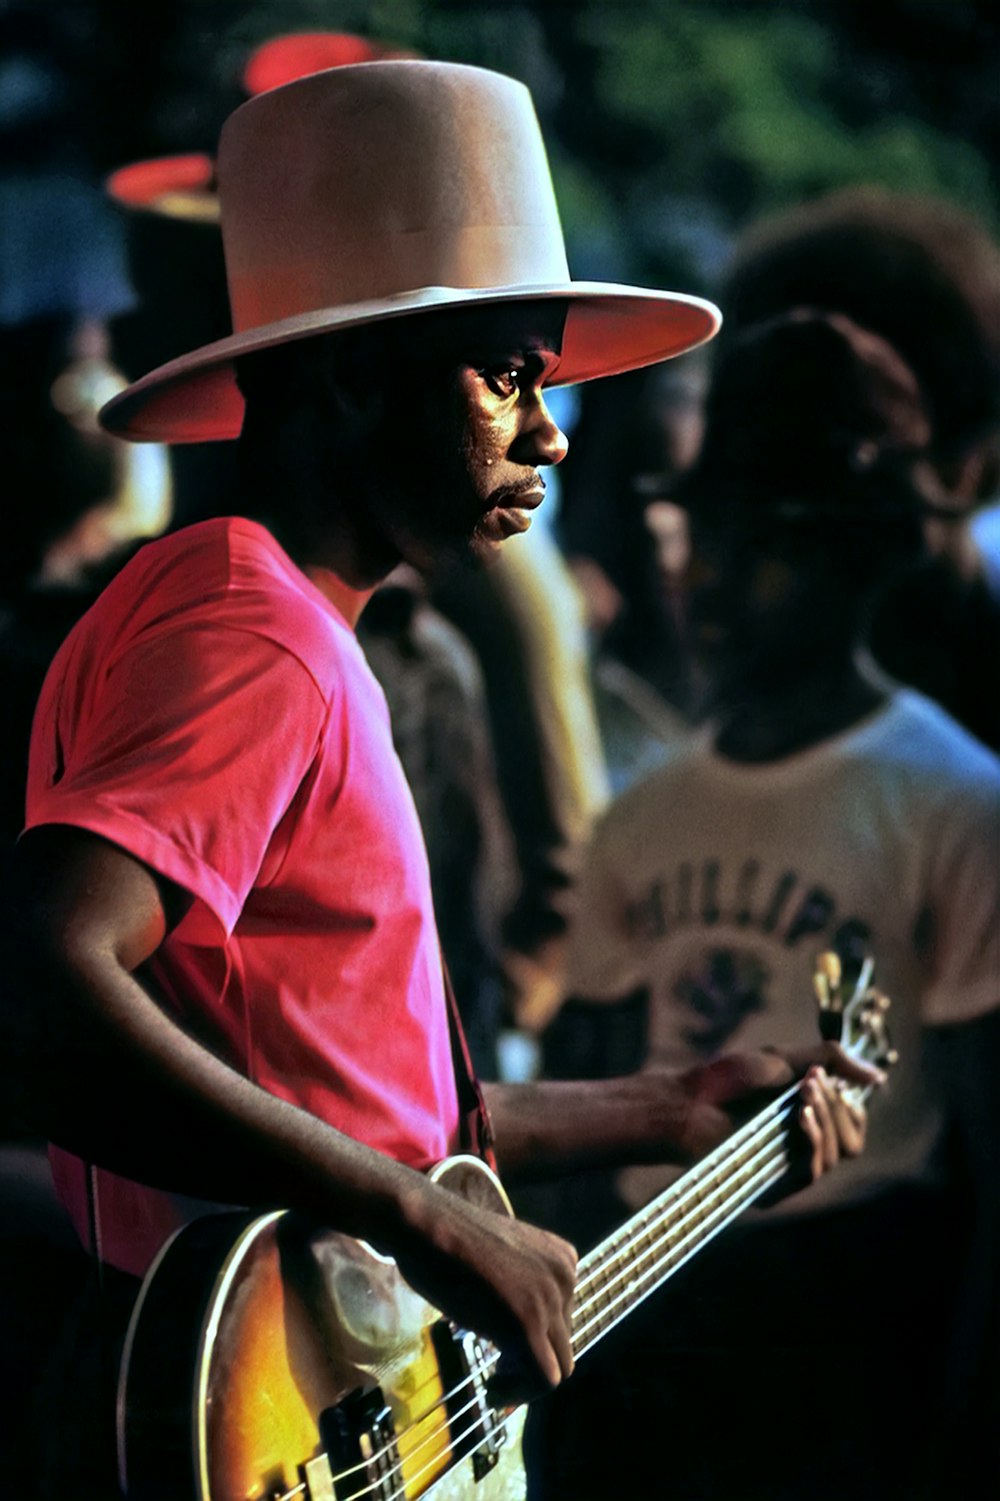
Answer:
354;305;568;572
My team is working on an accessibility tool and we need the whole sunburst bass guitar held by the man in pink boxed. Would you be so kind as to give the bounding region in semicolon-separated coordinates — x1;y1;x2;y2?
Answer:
117;956;895;1501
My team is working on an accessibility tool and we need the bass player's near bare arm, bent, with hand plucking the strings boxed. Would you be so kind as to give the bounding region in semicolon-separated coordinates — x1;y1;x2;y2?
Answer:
3;827;575;1384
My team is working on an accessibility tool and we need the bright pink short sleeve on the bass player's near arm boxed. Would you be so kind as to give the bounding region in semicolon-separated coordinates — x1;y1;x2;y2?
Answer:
27;624;329;934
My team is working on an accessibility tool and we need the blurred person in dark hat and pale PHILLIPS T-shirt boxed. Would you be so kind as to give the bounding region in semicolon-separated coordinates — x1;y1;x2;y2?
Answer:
538;311;1000;1501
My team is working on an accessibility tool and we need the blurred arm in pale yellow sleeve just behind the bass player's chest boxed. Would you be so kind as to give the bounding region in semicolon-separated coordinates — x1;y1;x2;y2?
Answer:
431;527;608;1044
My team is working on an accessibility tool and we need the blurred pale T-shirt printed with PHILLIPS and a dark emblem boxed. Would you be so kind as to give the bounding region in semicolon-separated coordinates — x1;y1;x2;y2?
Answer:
568;690;1000;1213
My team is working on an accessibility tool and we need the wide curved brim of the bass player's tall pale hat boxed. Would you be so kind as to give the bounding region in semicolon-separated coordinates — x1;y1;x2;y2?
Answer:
101;282;722;443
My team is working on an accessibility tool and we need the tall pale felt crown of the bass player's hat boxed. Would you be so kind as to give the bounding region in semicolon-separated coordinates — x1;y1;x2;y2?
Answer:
218;60;569;333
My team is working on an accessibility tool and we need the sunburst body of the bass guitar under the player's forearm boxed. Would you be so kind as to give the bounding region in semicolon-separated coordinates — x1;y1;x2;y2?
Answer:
119;1157;524;1501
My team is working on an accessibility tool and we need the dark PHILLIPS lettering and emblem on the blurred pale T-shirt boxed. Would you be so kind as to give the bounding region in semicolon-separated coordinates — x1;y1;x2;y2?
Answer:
626;859;872;1058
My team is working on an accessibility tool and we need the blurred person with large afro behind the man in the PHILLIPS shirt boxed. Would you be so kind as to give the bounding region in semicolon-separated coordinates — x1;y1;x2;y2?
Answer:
719;188;1000;752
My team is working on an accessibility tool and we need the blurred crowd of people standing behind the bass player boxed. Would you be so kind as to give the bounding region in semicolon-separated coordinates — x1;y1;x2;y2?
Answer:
0;20;1000;1501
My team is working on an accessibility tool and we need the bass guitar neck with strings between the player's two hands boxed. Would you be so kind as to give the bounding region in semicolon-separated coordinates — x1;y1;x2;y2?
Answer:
572;1085;799;1357
